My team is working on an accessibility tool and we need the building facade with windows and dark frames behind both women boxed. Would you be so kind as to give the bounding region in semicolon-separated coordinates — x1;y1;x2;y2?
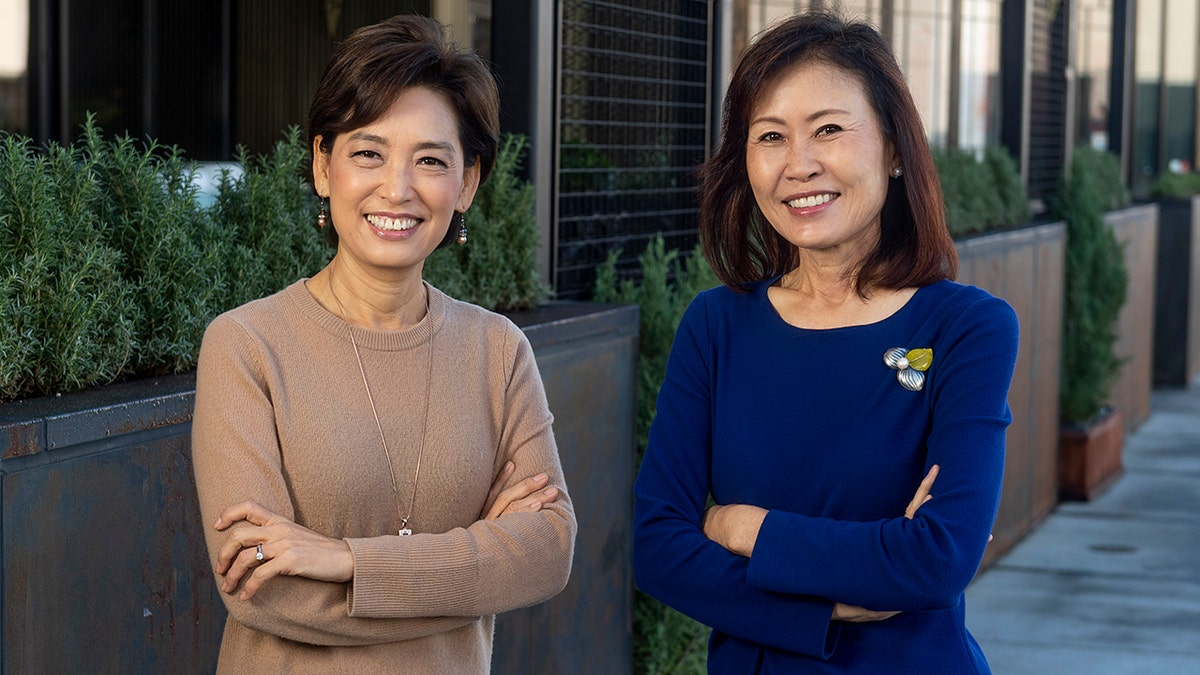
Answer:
0;0;1200;298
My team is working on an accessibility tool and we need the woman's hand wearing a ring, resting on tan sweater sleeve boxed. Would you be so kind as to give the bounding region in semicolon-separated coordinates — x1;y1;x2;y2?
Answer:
215;502;354;601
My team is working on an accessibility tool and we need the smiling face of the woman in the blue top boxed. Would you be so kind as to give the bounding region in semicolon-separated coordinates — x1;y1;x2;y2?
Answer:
746;61;900;261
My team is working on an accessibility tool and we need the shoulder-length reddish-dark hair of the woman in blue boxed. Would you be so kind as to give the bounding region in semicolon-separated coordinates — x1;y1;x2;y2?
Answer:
698;12;958;291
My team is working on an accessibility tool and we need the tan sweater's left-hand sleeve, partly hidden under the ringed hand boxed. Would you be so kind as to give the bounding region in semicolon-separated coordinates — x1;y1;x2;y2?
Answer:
192;316;478;646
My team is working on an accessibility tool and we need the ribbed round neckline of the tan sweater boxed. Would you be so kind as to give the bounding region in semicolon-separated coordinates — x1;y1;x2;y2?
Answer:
283;277;448;352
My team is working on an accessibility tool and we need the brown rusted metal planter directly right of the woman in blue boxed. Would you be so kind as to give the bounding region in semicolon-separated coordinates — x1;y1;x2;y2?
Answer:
956;222;1067;566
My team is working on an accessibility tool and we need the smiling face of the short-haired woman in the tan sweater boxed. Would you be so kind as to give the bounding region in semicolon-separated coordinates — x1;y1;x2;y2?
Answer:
313;86;479;275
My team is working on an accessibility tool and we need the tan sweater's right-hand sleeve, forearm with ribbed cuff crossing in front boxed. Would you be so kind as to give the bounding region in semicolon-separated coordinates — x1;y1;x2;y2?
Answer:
348;327;576;617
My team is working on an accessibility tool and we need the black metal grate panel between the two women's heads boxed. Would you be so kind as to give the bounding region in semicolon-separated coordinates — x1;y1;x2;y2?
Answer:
554;0;712;298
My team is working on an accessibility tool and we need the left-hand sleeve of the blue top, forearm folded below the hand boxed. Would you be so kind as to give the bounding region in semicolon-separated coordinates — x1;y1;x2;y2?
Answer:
634;295;840;658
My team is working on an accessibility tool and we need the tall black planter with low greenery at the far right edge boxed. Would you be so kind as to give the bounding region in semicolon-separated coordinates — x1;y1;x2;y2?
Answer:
1150;172;1200;387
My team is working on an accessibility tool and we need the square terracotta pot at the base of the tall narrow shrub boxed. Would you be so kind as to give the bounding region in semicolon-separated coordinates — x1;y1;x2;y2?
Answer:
1058;410;1124;501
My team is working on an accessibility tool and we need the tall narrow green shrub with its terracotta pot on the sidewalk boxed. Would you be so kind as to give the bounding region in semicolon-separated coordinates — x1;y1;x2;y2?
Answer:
1056;144;1128;500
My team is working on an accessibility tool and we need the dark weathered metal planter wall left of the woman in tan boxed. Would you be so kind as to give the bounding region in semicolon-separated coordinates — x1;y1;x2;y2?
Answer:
0;376;224;673
